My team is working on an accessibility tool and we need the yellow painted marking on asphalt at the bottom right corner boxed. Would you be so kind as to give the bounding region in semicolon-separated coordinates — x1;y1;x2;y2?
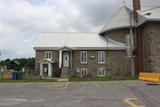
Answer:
123;98;145;107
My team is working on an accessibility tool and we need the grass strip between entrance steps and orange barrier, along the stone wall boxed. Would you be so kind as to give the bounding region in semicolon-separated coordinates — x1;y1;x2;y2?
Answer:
69;76;138;82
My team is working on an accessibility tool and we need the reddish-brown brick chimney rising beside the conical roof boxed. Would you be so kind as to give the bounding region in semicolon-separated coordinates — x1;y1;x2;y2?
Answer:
133;0;141;22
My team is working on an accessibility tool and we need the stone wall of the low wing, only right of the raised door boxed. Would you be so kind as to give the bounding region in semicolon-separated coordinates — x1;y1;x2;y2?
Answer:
73;51;128;76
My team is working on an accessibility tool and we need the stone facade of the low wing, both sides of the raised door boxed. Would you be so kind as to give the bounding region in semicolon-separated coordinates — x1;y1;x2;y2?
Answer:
36;51;128;76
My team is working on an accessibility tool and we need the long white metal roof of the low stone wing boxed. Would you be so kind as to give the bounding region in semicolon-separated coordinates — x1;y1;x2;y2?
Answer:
34;32;125;50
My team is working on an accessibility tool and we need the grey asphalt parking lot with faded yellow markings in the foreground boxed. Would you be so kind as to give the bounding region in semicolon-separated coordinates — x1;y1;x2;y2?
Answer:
0;81;160;107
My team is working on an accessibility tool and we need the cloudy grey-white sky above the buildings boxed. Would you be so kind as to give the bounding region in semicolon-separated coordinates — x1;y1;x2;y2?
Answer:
0;0;160;59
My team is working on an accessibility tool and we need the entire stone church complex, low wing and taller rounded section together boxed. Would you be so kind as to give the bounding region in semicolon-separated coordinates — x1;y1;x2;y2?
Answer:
34;0;160;77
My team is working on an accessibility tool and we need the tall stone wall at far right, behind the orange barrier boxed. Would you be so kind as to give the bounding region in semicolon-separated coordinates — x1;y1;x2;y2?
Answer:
141;22;160;72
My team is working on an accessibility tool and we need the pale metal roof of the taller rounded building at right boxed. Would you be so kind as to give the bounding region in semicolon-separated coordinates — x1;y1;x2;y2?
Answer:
99;6;160;34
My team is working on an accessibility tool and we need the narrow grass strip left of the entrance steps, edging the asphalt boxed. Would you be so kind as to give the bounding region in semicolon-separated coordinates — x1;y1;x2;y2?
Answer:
0;79;57;83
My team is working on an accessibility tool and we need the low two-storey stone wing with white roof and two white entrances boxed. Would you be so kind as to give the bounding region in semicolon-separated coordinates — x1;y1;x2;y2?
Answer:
34;33;126;78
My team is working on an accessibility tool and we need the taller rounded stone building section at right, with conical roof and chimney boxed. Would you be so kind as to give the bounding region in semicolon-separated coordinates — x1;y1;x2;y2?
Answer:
99;0;160;73
